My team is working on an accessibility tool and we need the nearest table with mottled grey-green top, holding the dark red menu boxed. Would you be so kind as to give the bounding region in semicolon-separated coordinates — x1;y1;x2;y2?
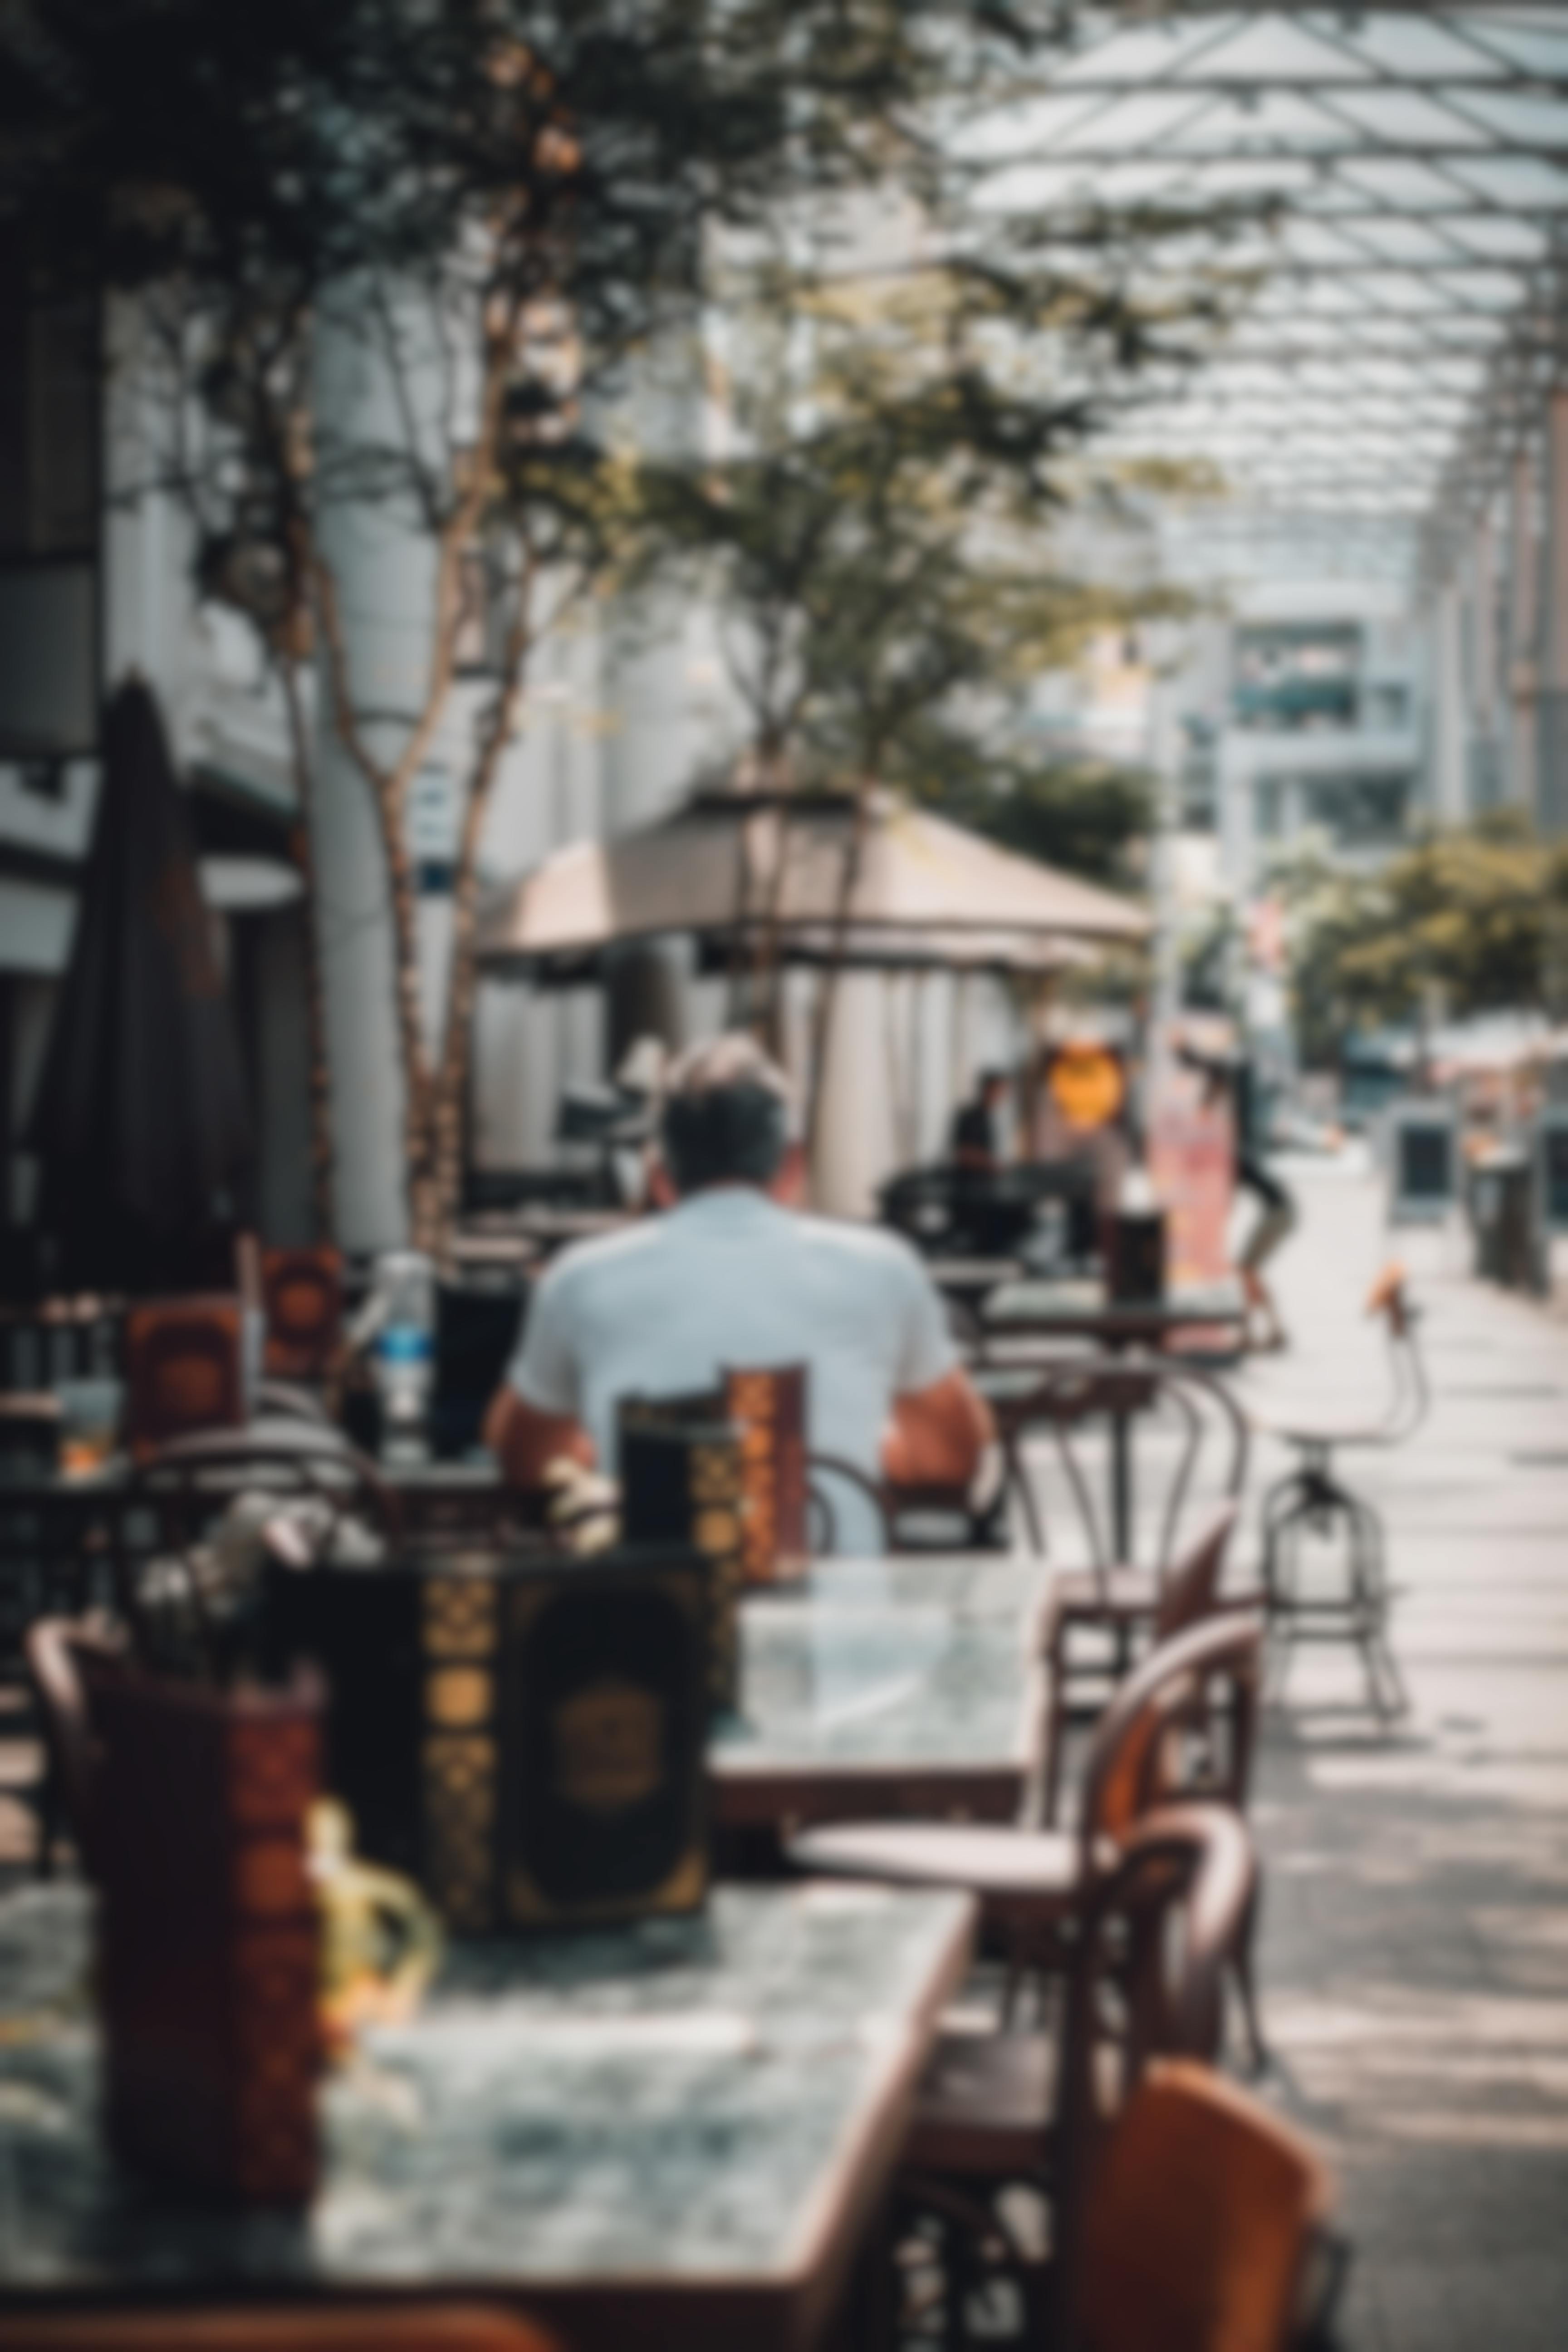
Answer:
0;1882;973;2352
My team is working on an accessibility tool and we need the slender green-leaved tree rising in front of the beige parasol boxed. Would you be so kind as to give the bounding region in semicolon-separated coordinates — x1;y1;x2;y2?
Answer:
632;250;1213;1101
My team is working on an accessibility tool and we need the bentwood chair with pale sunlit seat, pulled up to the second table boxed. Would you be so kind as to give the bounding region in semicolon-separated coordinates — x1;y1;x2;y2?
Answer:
788;1613;1262;1990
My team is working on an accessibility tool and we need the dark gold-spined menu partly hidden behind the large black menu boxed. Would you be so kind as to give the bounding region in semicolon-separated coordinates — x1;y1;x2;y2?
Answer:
618;1392;745;1715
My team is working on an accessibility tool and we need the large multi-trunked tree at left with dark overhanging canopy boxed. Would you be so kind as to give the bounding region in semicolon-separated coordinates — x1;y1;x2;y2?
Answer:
0;0;1105;1242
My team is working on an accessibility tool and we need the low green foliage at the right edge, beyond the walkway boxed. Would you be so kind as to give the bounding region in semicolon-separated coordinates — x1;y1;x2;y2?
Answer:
1274;811;1568;1063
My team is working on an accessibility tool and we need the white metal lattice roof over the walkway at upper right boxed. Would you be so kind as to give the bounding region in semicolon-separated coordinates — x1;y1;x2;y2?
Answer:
964;0;1568;578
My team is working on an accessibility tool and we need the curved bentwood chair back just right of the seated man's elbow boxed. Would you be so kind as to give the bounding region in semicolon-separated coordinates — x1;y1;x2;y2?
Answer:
985;1352;1251;1573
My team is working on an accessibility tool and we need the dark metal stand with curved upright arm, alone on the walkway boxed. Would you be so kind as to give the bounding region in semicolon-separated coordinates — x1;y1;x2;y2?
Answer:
1253;1265;1431;1717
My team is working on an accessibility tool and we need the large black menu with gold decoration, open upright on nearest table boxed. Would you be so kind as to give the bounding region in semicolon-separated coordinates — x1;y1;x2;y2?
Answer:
263;1548;708;1936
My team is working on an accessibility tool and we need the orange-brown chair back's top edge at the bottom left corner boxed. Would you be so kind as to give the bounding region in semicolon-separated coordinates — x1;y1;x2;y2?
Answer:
5;2298;559;2352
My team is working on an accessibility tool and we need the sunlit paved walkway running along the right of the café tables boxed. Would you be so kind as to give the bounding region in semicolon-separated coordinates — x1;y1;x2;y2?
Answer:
1241;1160;1568;2352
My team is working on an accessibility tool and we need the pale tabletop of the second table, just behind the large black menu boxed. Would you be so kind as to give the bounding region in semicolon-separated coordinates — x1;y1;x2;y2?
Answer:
710;1552;1049;1825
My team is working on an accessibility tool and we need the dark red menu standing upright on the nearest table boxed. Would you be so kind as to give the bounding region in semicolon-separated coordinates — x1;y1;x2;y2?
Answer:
87;1663;322;2206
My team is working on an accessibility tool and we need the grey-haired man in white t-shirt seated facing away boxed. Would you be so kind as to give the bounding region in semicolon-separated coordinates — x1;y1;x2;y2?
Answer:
484;1035;992;1552
